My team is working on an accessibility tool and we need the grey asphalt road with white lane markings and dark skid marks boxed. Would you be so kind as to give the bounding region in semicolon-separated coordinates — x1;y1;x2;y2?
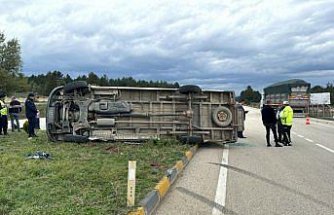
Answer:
157;109;334;215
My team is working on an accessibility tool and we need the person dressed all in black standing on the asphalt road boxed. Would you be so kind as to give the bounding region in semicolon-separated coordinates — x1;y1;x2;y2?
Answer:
261;101;282;147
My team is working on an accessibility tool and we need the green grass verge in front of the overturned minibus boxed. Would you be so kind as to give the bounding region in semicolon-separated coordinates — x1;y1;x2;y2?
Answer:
0;132;189;215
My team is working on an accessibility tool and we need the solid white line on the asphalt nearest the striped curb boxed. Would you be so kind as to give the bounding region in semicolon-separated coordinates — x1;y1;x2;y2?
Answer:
212;144;229;215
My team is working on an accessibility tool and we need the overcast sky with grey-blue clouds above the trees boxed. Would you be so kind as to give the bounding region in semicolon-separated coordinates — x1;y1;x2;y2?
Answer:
0;0;334;91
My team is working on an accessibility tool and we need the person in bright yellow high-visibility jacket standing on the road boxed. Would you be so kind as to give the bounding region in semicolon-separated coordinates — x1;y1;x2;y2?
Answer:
280;101;293;146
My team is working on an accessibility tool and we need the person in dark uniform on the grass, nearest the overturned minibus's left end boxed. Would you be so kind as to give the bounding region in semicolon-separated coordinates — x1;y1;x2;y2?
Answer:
25;93;37;138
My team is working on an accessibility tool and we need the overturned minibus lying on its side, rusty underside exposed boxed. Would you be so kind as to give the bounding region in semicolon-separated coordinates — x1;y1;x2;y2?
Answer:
46;81;244;143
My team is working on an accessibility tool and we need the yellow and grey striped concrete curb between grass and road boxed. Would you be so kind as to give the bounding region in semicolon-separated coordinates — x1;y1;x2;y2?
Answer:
128;145;198;215
